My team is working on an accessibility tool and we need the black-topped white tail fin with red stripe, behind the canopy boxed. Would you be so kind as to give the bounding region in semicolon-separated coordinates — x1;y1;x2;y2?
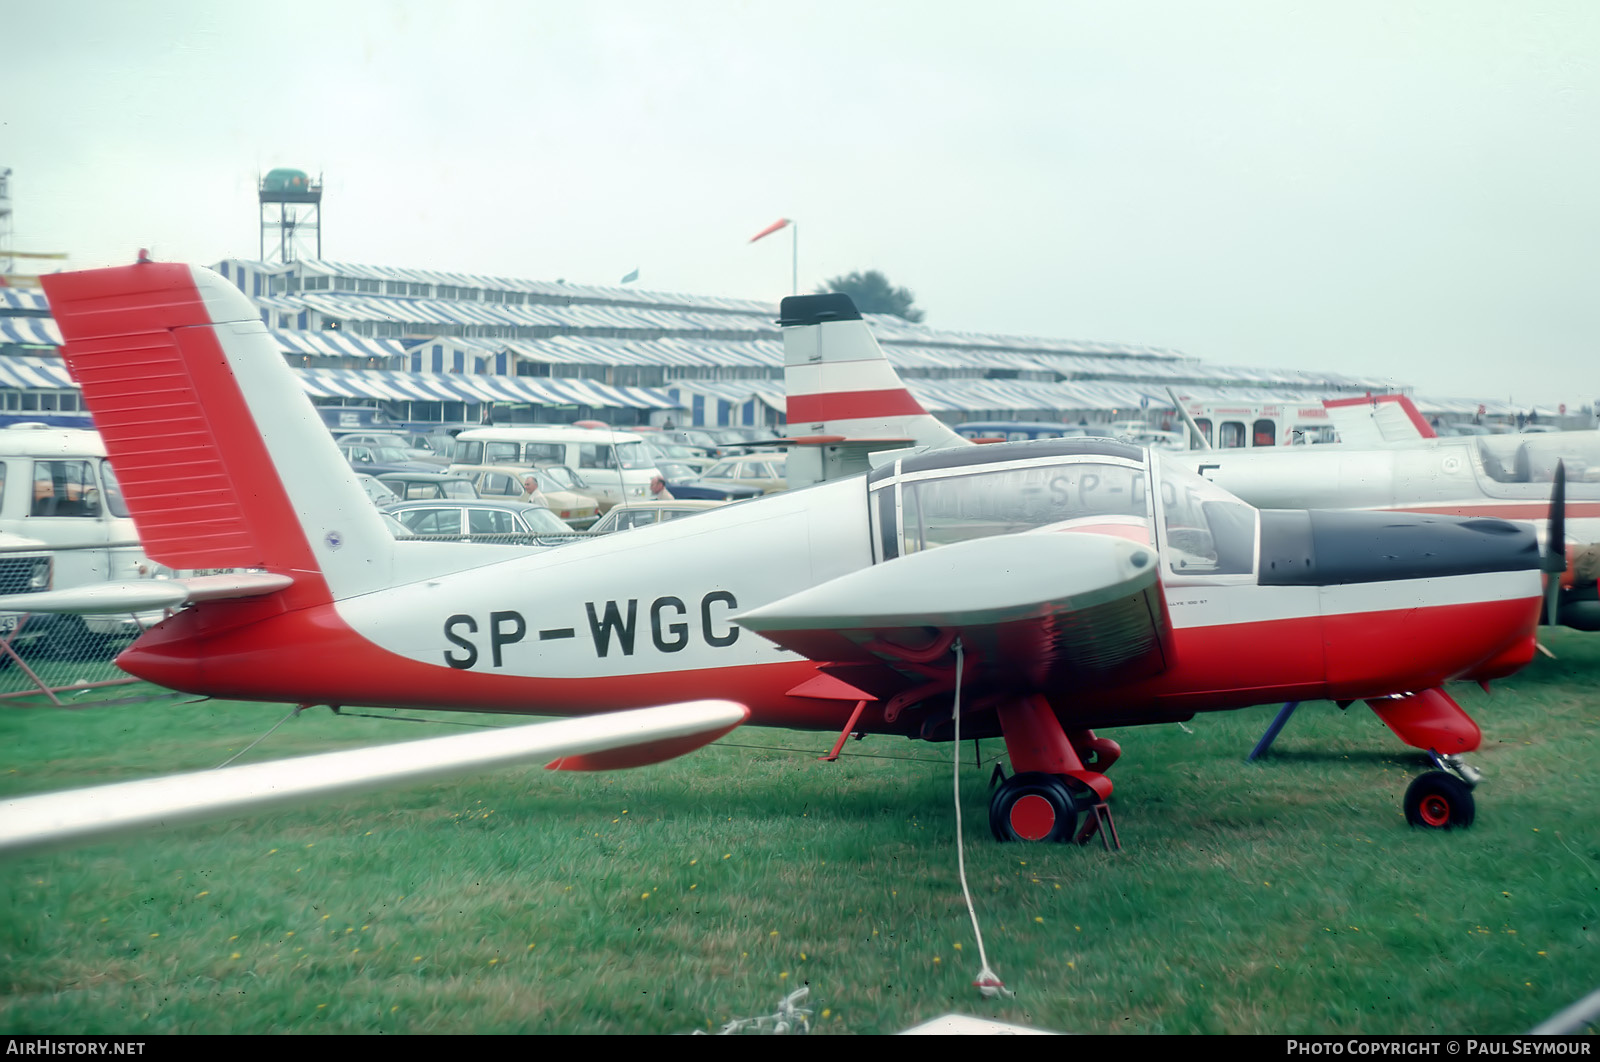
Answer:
778;293;968;448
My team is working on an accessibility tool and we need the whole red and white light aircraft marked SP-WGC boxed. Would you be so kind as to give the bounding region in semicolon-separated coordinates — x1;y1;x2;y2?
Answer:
0;264;1561;840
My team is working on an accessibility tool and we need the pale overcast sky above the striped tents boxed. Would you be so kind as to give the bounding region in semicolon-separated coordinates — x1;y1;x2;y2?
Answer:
0;0;1600;405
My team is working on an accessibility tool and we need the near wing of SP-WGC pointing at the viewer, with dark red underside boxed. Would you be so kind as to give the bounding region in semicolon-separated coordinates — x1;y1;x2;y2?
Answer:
734;531;1173;697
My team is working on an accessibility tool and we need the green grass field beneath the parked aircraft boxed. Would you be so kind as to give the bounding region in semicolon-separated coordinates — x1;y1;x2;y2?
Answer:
0;632;1600;1033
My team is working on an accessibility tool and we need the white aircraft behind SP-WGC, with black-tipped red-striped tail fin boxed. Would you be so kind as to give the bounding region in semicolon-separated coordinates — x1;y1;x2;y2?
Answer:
784;309;1600;630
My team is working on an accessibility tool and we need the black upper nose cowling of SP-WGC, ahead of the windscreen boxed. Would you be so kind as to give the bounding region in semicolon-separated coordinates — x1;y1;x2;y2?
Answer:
1261;509;1539;585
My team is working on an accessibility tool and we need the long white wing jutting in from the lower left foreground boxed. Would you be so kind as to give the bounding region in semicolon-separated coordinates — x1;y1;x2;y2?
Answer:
0;701;749;856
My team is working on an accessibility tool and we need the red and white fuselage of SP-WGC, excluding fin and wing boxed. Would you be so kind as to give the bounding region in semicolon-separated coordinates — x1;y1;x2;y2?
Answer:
120;440;1539;733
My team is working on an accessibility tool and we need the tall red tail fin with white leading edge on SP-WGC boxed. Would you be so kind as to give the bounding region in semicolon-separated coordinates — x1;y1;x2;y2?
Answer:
43;262;394;606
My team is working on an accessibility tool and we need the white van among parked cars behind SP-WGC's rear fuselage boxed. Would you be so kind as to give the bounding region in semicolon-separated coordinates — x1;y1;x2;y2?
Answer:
450;424;659;509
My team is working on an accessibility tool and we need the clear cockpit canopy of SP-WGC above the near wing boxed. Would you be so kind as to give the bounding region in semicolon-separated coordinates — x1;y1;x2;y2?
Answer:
867;440;1258;576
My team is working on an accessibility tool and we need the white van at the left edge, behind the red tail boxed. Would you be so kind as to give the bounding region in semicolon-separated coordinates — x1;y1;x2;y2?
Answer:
0;424;170;645
